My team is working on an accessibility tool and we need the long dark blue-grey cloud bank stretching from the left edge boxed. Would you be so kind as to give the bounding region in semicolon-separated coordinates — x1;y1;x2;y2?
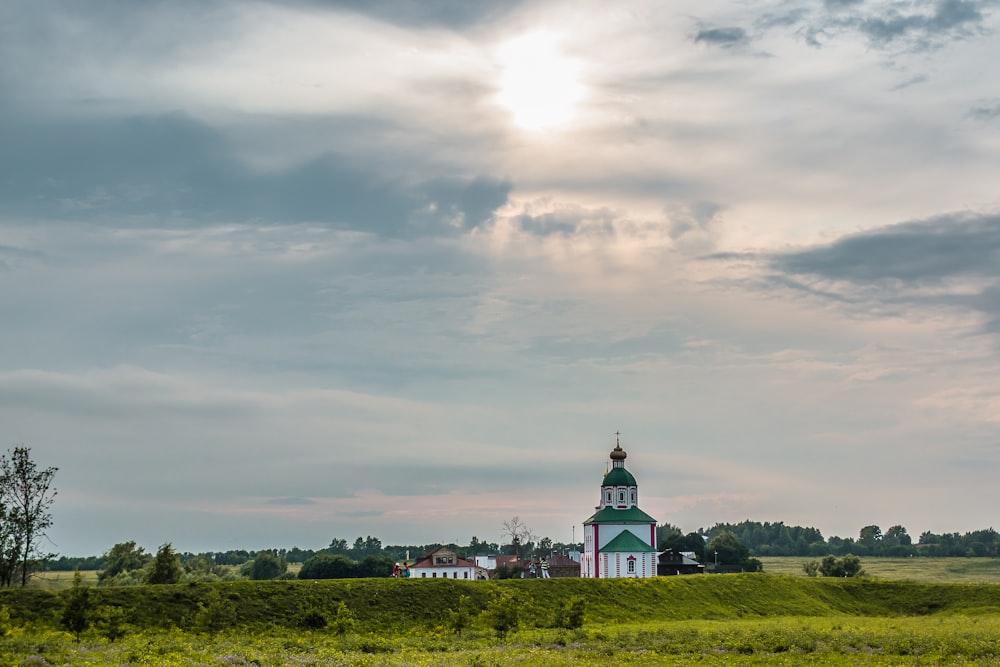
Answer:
0;114;512;237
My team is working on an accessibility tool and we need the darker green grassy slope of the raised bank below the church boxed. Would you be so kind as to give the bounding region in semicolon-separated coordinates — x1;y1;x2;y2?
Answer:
0;574;1000;633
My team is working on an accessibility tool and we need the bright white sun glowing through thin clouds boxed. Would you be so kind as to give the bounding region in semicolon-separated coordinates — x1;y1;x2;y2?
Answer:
497;32;583;130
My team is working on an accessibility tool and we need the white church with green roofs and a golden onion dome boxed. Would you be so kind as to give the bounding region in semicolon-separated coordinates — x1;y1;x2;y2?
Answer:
580;441;656;579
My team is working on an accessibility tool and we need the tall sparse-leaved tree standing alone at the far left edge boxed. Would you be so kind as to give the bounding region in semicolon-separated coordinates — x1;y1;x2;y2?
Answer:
0;447;58;586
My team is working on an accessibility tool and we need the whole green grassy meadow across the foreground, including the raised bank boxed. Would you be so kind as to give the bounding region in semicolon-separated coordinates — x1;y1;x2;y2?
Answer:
0;576;1000;667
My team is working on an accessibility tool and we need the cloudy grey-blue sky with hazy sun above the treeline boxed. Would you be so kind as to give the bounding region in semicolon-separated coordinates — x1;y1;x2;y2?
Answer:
0;0;1000;555
